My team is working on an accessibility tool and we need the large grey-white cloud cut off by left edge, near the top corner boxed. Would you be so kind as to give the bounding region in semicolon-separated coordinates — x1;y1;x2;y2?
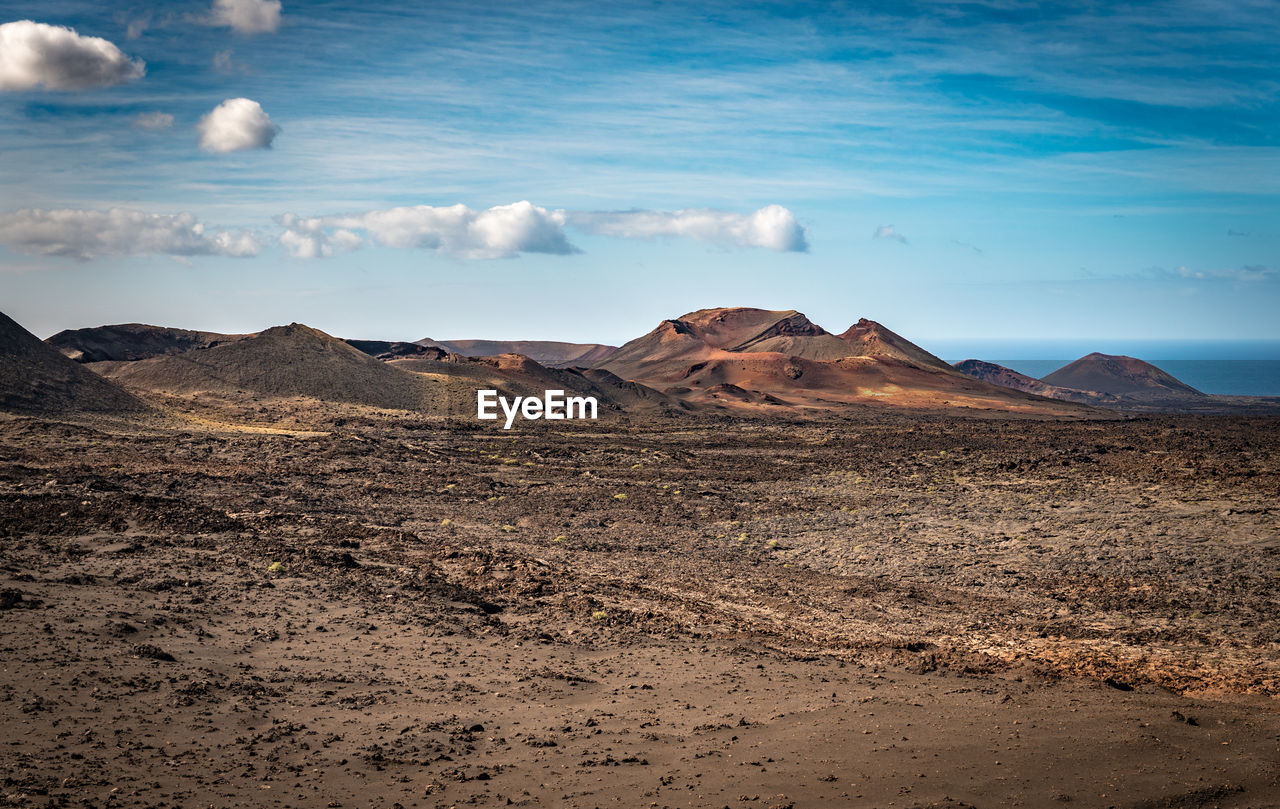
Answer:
0;19;146;91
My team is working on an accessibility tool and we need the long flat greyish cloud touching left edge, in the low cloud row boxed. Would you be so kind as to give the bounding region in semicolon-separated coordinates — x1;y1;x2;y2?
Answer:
0;207;262;261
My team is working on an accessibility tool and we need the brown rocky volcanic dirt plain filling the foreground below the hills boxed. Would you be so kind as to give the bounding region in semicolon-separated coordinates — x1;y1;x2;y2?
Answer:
0;411;1280;809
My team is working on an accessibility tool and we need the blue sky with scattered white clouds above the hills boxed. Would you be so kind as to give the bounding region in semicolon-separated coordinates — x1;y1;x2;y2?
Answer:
0;0;1280;344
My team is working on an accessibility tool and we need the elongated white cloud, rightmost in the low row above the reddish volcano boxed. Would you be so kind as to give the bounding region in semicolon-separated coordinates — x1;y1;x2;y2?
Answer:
568;205;809;252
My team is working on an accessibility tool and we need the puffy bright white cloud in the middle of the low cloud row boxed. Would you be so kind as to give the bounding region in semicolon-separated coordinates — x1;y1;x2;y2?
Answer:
279;202;579;259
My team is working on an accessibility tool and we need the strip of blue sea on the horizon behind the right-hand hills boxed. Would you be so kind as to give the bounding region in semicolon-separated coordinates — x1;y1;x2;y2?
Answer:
923;339;1280;396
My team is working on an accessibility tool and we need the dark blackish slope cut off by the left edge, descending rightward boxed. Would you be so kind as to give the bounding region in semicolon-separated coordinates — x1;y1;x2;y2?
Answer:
0;305;151;413
